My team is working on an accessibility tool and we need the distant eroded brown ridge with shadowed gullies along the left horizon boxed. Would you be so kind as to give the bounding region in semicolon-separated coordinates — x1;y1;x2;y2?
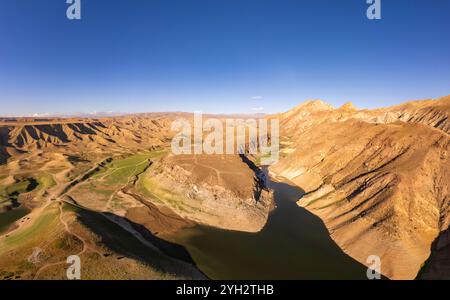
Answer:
0;115;177;164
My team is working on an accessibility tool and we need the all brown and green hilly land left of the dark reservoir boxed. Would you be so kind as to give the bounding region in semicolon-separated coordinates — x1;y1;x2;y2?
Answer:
0;113;272;279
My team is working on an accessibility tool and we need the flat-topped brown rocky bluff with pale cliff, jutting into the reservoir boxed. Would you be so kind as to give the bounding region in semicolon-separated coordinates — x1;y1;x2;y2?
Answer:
146;155;273;232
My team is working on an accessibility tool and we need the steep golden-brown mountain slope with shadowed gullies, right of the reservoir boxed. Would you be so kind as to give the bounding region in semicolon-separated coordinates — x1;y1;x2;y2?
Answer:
270;97;450;279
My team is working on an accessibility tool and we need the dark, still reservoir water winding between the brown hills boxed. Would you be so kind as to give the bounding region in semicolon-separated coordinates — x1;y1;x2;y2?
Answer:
171;176;367;279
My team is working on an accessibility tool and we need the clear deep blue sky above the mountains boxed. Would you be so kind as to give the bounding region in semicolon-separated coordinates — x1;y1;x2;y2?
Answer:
0;0;450;115
